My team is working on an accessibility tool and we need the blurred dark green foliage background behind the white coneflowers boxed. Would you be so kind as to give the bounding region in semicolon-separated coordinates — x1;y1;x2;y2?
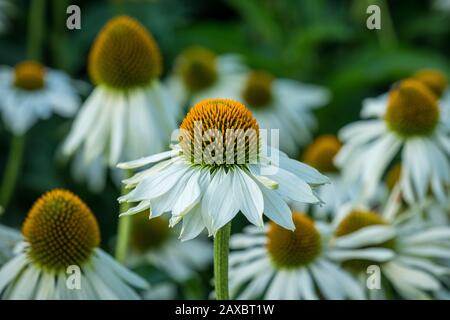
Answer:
0;0;450;298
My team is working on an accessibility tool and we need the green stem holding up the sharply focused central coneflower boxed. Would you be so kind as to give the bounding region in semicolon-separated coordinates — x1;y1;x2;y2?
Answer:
214;222;231;300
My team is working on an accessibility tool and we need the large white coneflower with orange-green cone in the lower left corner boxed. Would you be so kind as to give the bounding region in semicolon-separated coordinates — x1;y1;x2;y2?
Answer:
0;190;148;300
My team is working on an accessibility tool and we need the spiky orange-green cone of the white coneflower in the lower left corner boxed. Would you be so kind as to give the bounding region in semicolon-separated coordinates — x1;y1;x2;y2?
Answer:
22;190;100;271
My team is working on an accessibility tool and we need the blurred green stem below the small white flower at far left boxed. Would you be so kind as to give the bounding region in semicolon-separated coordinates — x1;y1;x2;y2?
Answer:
0;135;25;214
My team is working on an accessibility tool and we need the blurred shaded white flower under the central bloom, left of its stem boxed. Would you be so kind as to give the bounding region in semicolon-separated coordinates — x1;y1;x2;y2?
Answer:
126;212;213;282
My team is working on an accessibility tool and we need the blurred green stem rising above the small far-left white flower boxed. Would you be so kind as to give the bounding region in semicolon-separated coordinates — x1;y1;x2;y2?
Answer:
27;0;46;61
